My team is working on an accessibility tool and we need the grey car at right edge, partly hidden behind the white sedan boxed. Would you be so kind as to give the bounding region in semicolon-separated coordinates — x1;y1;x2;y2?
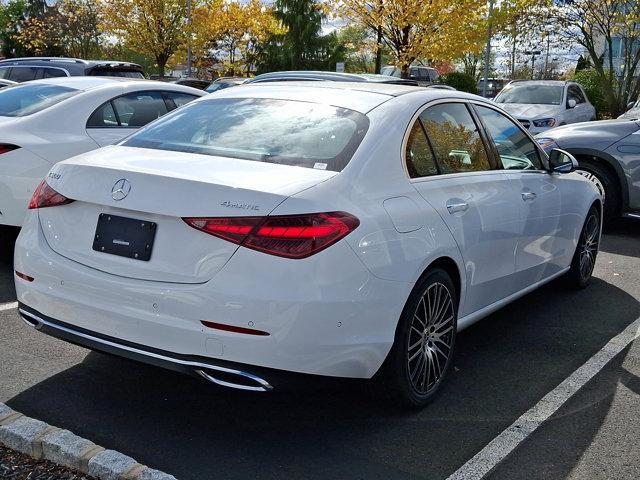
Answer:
537;118;640;221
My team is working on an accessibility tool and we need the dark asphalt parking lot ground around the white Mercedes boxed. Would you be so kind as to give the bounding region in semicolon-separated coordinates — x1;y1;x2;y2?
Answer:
0;222;640;479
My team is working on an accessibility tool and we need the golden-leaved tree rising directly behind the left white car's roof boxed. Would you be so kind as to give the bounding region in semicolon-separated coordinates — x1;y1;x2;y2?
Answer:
101;0;189;77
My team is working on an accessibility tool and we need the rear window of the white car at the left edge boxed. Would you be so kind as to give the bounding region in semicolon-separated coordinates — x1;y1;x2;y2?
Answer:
0;84;79;117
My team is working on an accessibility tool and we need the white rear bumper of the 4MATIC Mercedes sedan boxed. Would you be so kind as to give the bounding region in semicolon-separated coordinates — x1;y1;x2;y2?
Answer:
14;207;411;378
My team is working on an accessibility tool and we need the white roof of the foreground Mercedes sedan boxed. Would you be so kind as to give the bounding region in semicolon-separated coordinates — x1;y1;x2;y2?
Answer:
202;81;472;113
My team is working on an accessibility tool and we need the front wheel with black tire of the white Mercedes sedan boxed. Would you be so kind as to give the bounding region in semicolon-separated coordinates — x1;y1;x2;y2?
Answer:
567;205;600;288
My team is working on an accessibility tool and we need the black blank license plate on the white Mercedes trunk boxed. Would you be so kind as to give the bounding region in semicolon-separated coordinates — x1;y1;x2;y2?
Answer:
93;213;157;261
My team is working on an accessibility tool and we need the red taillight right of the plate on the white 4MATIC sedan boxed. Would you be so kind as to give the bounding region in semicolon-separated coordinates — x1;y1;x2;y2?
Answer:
183;212;360;258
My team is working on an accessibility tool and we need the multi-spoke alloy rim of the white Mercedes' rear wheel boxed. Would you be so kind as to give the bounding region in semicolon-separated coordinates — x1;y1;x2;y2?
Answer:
407;282;456;395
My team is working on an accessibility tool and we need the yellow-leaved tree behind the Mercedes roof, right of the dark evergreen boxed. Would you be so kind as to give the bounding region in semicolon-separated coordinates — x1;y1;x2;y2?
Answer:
338;0;486;77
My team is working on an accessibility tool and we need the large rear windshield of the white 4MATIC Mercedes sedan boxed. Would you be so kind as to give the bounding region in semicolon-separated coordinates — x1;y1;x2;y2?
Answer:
124;98;369;172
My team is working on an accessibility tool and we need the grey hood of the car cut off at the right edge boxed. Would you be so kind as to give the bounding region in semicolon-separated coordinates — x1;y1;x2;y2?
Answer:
538;119;640;150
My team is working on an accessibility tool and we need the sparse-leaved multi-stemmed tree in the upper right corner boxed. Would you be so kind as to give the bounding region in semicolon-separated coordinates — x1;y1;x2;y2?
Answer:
554;0;640;117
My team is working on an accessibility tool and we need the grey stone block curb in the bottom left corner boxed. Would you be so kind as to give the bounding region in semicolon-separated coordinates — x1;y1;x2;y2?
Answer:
0;402;176;480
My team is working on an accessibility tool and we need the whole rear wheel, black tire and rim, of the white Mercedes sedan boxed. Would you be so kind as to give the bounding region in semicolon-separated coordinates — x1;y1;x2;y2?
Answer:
376;268;458;408
